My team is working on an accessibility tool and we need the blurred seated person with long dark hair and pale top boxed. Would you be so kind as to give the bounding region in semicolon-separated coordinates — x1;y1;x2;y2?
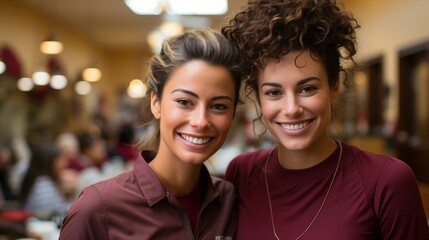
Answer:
19;142;71;219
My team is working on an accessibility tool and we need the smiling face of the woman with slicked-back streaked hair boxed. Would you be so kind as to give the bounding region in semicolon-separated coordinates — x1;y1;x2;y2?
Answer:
151;60;235;164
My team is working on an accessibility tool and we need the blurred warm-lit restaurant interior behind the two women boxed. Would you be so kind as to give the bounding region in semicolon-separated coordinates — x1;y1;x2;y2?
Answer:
0;0;429;238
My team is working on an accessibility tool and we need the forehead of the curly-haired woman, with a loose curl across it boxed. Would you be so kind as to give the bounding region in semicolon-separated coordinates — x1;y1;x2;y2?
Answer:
258;50;327;82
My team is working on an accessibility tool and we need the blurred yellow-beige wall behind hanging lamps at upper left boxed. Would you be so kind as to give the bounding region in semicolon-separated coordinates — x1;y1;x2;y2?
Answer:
0;0;150;132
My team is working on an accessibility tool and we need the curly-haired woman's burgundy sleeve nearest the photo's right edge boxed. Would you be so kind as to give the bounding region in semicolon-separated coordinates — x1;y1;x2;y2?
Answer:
374;159;429;240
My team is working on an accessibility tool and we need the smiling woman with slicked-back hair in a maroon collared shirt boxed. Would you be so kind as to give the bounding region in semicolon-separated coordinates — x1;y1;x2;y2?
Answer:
60;29;241;240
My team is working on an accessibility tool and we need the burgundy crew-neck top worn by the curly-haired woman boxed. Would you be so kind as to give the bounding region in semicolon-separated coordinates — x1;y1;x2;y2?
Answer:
225;143;429;240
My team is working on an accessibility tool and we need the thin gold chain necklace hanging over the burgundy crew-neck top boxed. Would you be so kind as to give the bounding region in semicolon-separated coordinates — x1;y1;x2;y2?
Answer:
264;142;343;240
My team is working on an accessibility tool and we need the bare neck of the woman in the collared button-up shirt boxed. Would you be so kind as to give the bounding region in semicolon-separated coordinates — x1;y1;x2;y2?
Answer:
149;154;201;197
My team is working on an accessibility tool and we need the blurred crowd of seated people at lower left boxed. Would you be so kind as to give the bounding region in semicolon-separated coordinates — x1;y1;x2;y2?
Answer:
0;124;138;239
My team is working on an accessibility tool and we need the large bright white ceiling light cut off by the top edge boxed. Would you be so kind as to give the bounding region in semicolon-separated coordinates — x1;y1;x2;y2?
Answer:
124;0;228;15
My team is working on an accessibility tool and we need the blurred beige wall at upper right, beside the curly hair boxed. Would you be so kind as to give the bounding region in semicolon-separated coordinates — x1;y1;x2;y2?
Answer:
344;0;429;121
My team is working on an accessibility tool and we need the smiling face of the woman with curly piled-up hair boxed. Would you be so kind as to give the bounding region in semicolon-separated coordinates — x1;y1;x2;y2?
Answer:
258;51;338;151
